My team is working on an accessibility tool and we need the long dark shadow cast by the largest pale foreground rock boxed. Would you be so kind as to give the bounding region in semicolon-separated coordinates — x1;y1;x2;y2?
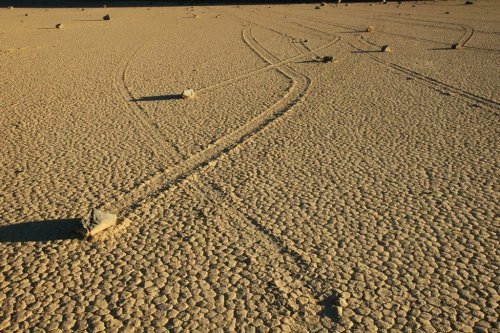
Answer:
0;218;82;243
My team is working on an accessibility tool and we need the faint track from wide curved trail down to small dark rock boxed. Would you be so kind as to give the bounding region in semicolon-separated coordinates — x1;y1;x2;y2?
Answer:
188;177;340;331
